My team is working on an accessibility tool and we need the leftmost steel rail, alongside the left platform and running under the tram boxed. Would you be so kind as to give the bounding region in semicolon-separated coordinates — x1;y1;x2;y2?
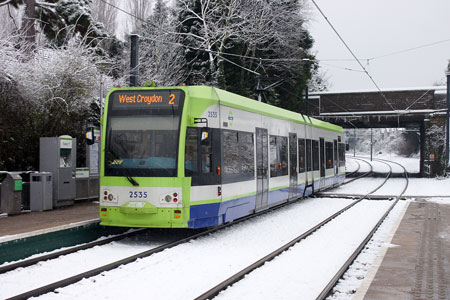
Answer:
0;228;147;274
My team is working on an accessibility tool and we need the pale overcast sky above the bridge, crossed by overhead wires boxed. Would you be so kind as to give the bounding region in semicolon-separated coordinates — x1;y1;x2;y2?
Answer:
308;0;450;91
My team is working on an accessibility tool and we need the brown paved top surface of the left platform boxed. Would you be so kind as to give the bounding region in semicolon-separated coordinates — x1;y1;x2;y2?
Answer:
0;201;99;239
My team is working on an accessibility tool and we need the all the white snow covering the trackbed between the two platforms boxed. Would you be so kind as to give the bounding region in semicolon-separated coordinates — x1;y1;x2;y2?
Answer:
0;154;450;300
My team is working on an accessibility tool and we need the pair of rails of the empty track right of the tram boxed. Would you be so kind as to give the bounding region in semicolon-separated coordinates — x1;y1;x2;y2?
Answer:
195;161;408;300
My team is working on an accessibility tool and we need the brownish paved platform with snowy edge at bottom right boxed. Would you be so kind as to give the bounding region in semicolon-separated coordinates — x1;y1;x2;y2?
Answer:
353;199;450;299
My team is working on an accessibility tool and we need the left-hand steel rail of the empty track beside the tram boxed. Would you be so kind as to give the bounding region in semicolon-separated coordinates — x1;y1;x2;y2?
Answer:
194;161;392;300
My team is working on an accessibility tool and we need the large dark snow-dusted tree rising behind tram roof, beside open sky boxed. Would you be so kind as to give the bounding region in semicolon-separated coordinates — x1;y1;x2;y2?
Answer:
177;0;314;111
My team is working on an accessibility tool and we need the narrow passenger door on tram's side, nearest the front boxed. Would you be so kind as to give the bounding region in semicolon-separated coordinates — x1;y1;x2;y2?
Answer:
255;128;269;212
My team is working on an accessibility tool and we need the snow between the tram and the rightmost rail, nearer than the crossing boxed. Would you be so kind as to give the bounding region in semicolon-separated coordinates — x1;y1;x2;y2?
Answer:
18;198;398;299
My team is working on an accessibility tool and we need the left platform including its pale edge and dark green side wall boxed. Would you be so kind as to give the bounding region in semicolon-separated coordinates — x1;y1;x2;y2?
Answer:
0;202;106;265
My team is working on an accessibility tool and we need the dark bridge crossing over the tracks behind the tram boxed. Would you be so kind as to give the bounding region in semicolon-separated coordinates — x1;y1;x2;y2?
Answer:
304;86;447;176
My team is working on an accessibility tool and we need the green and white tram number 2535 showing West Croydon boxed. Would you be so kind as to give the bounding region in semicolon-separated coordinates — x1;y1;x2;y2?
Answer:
100;86;345;228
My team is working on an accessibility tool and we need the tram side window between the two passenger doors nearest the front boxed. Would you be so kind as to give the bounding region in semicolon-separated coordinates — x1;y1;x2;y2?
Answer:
270;135;288;177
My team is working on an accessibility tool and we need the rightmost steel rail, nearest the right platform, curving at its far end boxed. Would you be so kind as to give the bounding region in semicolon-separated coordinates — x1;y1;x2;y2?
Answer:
316;159;409;300
